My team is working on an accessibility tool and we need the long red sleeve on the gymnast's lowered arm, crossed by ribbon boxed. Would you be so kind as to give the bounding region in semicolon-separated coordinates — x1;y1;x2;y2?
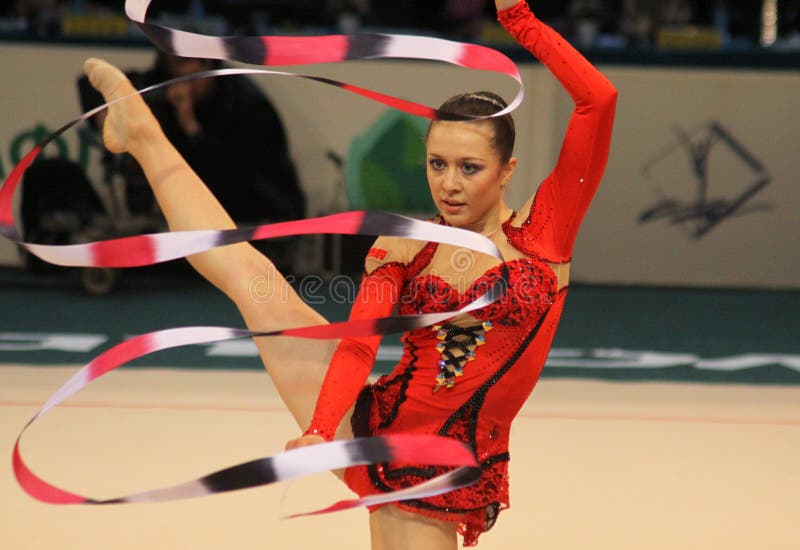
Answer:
306;260;405;441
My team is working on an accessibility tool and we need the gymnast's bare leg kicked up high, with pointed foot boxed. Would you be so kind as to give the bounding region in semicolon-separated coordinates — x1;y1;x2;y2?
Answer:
84;59;344;437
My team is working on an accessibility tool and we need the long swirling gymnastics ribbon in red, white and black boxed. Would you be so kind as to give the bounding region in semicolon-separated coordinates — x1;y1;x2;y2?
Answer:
0;0;523;515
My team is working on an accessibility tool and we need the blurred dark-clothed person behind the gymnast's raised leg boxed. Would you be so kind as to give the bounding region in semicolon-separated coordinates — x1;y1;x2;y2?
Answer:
79;52;305;269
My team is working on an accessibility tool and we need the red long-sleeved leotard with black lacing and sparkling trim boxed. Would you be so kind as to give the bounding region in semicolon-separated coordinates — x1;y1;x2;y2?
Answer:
306;2;616;546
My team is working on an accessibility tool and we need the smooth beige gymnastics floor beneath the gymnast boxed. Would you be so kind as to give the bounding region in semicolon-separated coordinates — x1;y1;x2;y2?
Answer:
0;364;800;550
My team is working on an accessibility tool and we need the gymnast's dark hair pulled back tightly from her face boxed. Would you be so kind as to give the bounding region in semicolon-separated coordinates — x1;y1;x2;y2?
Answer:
425;92;517;163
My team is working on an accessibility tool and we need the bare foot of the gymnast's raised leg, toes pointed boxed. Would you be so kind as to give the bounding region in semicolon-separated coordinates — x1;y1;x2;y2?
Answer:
83;58;159;153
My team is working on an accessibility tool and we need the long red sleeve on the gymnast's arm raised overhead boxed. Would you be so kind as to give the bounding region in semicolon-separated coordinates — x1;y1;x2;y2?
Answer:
498;0;617;262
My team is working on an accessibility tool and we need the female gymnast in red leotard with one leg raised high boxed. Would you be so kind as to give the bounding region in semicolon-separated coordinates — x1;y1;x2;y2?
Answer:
85;0;617;550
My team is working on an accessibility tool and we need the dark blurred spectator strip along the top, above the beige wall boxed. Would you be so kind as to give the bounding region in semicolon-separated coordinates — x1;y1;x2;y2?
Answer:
0;0;800;49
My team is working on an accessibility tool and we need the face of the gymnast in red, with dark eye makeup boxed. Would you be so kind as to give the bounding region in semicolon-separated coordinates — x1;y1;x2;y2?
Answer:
427;121;517;233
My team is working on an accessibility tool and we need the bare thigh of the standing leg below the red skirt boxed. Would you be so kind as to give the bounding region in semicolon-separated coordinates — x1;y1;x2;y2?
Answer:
369;505;458;550
